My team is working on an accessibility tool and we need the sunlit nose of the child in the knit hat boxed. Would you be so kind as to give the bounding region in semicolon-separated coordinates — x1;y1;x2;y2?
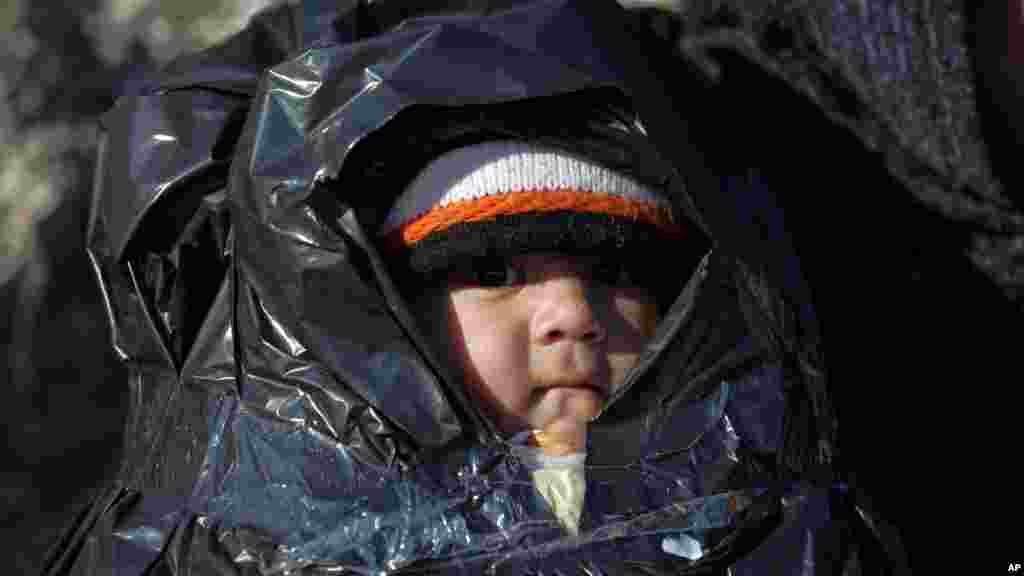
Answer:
531;274;605;344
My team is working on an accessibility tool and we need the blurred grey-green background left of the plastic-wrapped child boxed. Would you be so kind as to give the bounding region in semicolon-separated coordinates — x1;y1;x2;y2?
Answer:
0;0;280;574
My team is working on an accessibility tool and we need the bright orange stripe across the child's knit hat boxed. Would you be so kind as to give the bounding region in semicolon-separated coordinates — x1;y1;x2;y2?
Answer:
389;190;682;246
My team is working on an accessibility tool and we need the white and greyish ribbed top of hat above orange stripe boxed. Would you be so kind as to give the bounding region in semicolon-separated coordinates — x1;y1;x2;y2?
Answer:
380;140;670;235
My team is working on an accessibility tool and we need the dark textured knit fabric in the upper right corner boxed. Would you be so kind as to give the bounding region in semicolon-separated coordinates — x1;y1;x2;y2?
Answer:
659;0;1024;301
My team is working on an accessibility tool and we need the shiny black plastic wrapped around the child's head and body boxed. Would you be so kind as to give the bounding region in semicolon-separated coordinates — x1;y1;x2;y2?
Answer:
49;0;905;576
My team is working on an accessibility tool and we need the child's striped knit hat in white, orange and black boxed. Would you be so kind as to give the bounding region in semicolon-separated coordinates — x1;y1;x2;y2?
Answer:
379;140;683;280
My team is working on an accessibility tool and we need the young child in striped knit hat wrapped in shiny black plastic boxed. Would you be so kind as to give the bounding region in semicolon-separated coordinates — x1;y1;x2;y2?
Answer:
51;1;909;575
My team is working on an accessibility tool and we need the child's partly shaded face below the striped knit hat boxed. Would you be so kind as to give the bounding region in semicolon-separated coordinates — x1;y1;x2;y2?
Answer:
436;254;658;438
